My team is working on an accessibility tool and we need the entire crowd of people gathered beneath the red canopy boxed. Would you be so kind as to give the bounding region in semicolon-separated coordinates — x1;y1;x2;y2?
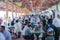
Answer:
0;9;60;40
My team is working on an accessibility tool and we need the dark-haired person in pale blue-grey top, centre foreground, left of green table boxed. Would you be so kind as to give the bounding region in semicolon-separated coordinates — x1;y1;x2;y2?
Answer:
22;22;31;40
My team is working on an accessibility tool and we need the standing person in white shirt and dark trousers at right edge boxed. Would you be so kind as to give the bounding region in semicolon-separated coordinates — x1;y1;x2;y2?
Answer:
53;14;60;40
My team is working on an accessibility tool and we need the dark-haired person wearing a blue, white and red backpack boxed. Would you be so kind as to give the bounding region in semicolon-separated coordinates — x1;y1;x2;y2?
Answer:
42;19;55;40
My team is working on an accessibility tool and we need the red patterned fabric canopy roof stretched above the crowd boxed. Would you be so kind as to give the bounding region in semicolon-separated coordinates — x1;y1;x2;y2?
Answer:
9;0;60;11
